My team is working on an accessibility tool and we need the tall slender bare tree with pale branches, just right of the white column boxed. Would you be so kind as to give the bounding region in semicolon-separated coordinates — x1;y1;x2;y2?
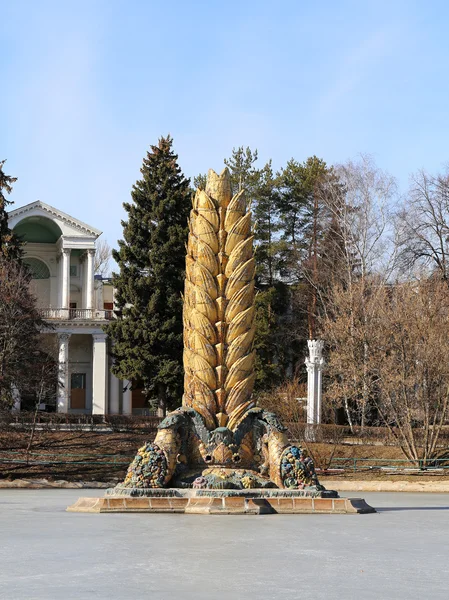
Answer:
319;156;396;427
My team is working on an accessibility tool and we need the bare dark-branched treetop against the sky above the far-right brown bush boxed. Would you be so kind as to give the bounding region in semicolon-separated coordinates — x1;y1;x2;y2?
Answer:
397;170;449;281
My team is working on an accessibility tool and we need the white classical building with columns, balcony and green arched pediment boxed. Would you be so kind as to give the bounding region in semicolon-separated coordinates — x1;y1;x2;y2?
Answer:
8;201;144;415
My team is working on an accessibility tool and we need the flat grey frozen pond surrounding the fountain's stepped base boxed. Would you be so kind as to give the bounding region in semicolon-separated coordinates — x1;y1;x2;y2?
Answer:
0;490;449;600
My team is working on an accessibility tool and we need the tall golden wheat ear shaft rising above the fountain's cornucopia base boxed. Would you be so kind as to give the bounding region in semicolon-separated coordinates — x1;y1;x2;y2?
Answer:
183;169;255;430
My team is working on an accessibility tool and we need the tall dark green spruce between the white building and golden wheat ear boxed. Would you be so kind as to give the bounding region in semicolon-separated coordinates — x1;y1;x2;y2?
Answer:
106;136;191;412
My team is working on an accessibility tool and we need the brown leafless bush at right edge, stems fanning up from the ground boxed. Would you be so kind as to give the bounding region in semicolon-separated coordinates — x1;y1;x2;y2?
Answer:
376;278;449;462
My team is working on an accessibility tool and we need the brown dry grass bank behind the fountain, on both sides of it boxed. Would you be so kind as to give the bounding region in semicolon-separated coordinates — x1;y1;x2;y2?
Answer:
0;431;449;483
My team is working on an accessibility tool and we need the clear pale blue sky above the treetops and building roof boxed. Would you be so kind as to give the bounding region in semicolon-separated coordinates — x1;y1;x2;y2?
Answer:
0;0;449;253
